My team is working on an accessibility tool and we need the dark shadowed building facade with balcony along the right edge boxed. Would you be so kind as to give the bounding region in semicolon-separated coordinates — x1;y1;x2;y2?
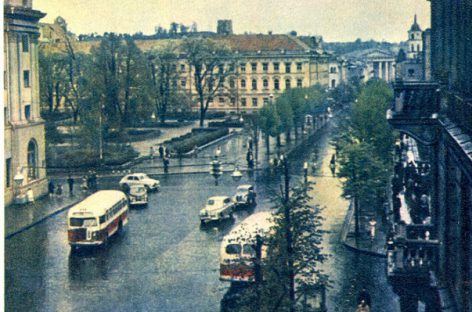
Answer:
389;0;472;312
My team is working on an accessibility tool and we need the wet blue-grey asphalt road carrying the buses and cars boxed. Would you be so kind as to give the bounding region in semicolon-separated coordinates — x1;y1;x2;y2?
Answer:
5;123;399;312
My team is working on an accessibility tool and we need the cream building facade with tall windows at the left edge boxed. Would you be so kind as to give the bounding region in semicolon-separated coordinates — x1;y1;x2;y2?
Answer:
3;0;47;205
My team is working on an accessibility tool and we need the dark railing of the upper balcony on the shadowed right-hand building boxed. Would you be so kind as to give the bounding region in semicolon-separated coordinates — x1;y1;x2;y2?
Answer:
388;80;440;119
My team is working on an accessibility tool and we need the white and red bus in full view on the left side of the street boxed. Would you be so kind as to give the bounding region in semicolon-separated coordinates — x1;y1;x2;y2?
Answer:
67;190;128;248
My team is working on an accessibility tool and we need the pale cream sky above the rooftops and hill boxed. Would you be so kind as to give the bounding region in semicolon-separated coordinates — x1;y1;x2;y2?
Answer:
33;0;430;42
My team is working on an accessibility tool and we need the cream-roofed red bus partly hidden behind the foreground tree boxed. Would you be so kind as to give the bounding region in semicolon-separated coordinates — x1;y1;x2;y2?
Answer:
220;212;274;282
